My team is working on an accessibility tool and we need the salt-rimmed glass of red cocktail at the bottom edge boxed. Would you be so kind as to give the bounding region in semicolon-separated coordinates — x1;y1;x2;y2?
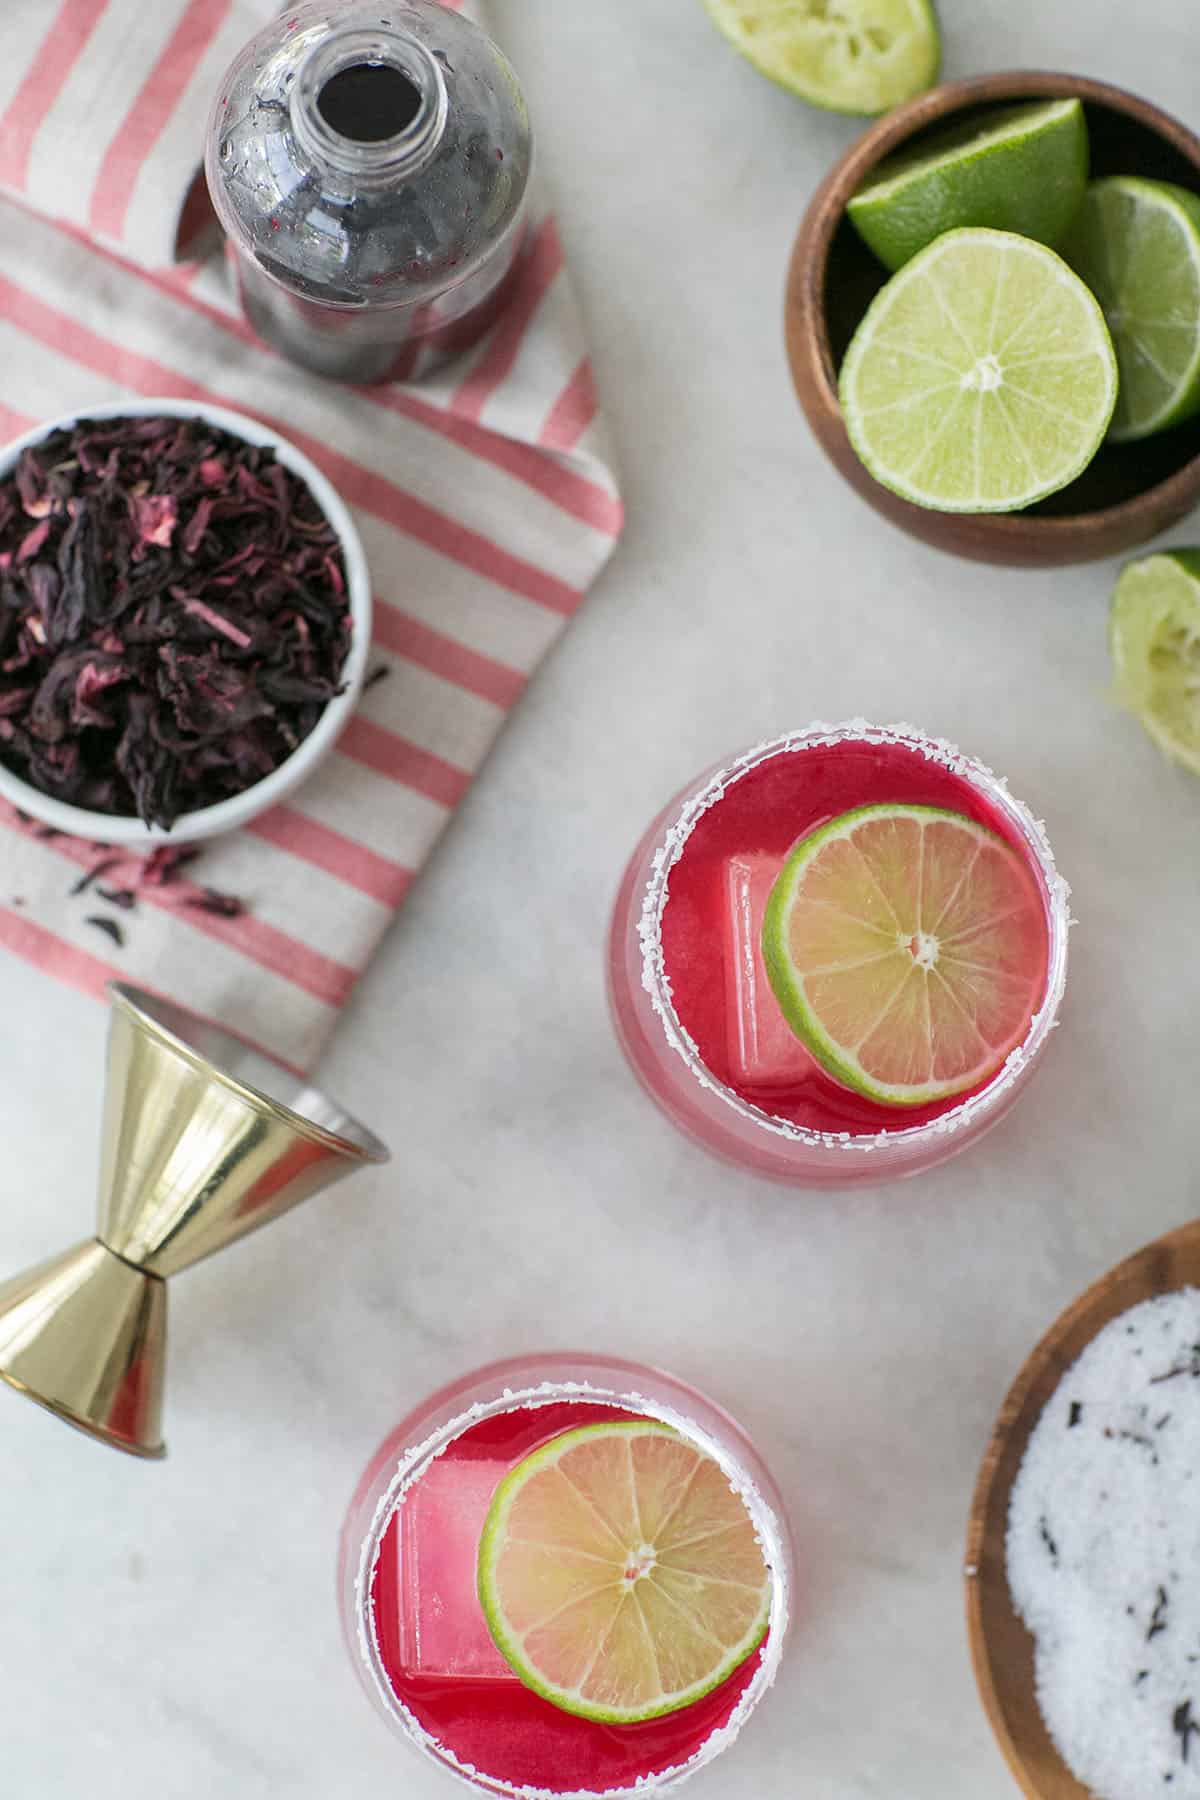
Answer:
338;1354;793;1796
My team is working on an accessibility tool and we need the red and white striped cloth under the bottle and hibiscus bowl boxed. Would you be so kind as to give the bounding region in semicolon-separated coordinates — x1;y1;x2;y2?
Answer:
0;0;621;1067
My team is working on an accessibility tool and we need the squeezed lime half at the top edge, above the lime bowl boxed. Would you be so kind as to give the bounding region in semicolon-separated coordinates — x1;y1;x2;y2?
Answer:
705;0;941;113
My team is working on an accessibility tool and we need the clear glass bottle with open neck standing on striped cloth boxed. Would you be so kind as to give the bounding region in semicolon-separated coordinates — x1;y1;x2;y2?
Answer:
205;0;533;382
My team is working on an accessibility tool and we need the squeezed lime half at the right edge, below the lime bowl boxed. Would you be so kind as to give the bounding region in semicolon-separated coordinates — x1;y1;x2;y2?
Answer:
1108;549;1200;776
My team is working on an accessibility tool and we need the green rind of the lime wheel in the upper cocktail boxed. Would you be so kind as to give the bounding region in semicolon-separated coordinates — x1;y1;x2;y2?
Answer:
763;805;1043;1107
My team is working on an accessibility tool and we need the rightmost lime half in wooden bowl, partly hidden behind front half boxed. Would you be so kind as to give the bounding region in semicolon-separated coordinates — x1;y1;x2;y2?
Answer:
1063;175;1200;443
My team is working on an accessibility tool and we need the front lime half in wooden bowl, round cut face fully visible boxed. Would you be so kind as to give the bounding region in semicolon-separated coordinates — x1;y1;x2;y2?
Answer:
840;229;1117;513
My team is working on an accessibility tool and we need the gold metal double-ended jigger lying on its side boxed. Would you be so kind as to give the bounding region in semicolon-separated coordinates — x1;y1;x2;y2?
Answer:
0;985;389;1456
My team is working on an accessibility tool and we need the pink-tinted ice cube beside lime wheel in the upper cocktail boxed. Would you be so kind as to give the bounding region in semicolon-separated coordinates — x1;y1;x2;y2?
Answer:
725;851;813;1087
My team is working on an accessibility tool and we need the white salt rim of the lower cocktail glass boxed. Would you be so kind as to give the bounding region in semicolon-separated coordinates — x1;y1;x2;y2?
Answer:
354;1381;790;1800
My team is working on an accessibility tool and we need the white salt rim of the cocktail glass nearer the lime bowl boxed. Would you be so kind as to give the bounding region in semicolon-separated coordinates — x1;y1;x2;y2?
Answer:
637;718;1074;1152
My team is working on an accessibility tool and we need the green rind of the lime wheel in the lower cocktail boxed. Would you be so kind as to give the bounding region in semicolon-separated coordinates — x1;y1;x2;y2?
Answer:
477;1418;770;1724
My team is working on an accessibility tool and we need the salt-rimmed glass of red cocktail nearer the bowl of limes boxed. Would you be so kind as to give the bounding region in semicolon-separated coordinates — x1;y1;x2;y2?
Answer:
608;720;1070;1186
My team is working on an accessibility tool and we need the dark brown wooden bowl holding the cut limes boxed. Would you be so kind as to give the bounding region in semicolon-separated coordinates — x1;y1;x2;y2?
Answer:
786;70;1200;567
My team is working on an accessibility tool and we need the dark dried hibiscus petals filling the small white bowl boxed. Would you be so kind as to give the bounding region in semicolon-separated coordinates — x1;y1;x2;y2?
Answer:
0;418;351;828
